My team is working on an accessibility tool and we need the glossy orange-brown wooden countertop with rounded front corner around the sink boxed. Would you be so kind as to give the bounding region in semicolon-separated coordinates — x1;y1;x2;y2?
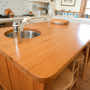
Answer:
0;22;90;80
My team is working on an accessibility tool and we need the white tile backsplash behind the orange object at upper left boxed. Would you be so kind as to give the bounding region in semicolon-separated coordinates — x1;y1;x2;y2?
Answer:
0;0;31;15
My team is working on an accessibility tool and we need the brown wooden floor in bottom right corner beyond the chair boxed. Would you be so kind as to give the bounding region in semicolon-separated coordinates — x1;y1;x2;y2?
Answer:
72;63;90;90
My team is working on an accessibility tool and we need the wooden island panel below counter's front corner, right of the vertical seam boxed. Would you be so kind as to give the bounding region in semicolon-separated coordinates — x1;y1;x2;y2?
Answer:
8;60;44;90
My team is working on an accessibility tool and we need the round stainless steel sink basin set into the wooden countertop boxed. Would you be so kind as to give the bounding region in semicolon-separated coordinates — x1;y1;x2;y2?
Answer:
5;30;40;39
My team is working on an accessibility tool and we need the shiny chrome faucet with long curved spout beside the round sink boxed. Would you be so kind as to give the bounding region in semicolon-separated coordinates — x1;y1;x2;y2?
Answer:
13;16;47;42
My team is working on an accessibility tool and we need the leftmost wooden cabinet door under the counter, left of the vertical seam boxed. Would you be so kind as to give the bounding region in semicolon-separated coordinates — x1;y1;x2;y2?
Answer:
0;55;11;90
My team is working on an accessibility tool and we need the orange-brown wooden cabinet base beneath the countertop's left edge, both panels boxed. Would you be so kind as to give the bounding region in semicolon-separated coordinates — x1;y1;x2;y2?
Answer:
0;55;44;90
